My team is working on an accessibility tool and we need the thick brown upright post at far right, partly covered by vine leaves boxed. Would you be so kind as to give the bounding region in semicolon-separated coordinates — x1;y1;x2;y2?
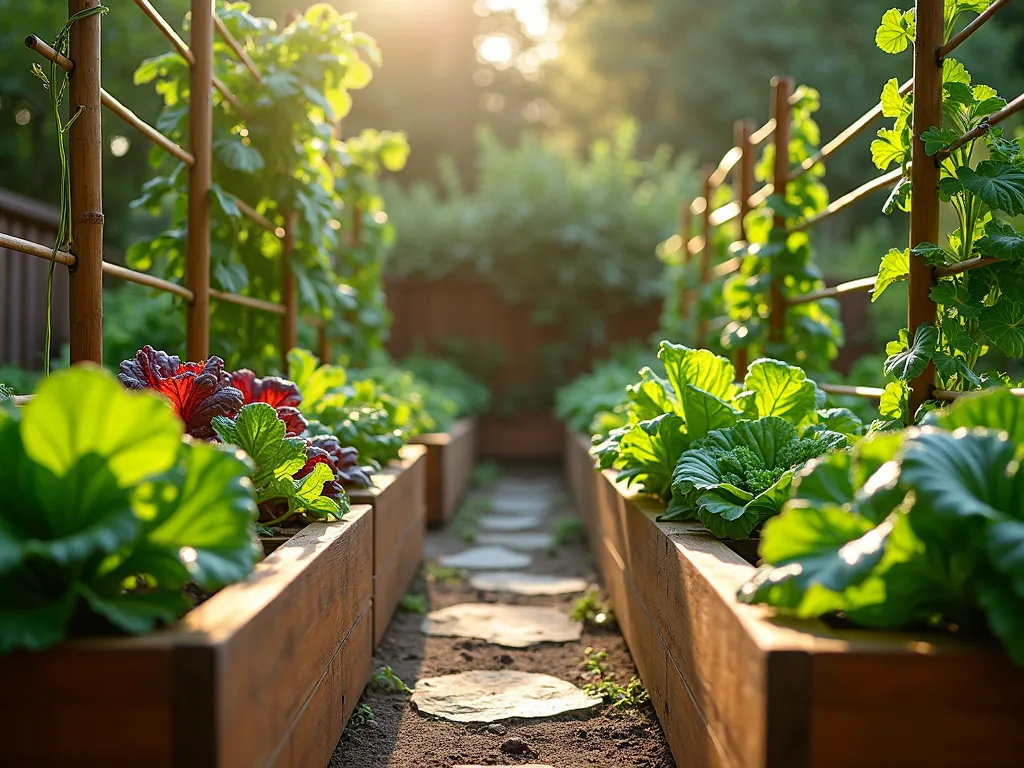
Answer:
907;0;945;423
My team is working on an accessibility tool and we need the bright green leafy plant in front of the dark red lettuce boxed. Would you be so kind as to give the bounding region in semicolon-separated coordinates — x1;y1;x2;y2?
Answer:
213;402;348;525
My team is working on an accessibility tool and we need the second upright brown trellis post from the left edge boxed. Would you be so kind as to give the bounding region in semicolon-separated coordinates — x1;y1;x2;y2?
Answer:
185;0;213;360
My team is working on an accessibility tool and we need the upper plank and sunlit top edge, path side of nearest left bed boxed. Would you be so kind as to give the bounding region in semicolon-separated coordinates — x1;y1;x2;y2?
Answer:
176;506;373;768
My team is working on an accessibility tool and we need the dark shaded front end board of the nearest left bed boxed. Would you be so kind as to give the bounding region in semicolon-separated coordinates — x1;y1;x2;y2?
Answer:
0;644;172;768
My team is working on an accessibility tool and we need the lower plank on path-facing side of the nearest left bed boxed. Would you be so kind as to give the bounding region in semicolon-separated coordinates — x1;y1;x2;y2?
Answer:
266;600;373;768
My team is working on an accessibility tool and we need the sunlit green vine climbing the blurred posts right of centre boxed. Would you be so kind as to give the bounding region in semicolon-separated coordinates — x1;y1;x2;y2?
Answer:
721;87;843;371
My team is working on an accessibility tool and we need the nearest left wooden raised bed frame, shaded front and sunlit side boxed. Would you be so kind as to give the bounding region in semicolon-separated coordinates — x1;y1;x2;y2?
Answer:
0;506;373;768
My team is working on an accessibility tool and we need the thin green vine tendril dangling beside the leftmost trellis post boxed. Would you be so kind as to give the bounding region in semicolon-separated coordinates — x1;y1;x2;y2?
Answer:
32;5;110;377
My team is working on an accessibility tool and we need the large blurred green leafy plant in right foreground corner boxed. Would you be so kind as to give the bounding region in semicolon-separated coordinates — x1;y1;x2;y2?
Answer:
739;389;1024;665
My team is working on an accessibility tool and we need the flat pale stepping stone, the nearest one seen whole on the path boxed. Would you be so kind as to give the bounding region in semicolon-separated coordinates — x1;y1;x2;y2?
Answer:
413;671;602;723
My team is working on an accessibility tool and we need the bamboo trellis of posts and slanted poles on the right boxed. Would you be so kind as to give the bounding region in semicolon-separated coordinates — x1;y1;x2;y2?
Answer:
680;0;1024;419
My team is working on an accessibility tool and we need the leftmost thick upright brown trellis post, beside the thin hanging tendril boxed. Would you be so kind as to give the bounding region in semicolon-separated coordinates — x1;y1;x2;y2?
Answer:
66;0;103;365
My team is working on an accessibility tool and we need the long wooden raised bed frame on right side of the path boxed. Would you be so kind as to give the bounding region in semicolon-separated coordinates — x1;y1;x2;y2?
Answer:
570;439;1024;768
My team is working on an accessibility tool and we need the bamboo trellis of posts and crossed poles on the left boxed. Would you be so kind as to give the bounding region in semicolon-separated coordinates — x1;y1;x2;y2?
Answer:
0;0;329;372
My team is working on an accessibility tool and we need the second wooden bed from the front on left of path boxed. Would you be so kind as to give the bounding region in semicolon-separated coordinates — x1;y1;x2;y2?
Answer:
349;445;427;647
